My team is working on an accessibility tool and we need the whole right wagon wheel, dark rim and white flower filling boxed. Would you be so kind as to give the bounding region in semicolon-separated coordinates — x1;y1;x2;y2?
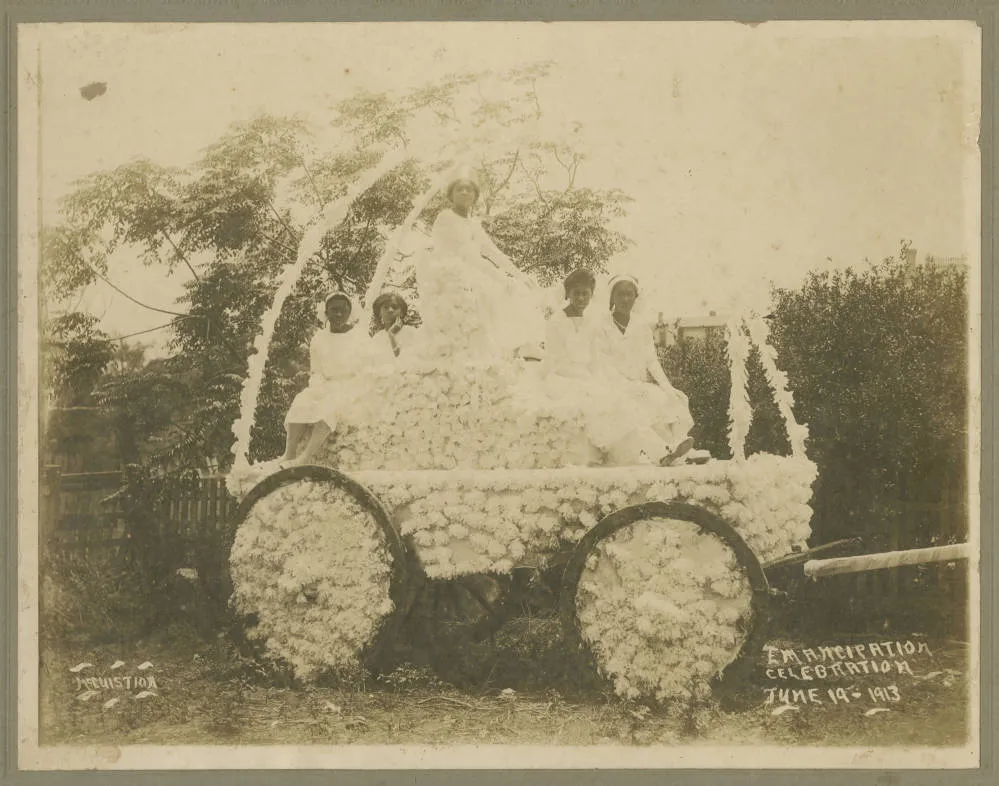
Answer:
559;502;769;708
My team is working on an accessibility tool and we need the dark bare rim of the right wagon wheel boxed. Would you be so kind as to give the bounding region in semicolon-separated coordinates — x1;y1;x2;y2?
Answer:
558;502;770;690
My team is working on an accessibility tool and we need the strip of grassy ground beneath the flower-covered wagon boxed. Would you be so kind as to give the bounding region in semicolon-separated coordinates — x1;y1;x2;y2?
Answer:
40;618;968;746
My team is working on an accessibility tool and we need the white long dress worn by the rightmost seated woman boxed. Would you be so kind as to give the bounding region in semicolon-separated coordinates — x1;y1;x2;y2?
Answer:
601;312;694;449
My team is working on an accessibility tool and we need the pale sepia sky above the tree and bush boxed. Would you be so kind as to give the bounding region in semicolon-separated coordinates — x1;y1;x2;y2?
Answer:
22;22;980;356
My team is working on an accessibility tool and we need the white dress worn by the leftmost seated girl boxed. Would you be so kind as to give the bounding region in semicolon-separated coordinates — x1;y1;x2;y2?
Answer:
284;328;371;431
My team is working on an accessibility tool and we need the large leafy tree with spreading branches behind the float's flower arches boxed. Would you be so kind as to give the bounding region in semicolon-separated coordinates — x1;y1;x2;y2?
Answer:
43;64;627;468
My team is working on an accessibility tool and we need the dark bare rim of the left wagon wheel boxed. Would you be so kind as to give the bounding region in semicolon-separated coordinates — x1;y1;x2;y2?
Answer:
222;464;425;661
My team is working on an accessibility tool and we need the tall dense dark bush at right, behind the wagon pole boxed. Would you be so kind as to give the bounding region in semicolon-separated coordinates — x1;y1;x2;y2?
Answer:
772;258;968;547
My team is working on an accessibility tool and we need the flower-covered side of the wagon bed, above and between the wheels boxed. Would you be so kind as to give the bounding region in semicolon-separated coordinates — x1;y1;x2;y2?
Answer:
352;453;816;578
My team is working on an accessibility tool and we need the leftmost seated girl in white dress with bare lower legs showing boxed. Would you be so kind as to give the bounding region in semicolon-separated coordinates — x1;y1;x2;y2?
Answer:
278;292;367;464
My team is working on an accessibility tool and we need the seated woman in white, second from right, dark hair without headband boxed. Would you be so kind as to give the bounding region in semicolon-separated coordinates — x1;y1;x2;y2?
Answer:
541;270;670;466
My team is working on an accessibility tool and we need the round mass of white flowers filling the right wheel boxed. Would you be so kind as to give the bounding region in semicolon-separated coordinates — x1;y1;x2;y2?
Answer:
576;519;752;703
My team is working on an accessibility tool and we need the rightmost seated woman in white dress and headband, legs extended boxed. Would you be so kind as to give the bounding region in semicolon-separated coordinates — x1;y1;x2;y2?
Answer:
602;275;701;463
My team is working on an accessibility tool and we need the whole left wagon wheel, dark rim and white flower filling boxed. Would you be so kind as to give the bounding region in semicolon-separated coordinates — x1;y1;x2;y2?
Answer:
223;466;420;679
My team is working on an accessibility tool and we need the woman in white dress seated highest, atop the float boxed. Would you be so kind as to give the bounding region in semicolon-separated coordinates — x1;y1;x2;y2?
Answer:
416;169;543;364
